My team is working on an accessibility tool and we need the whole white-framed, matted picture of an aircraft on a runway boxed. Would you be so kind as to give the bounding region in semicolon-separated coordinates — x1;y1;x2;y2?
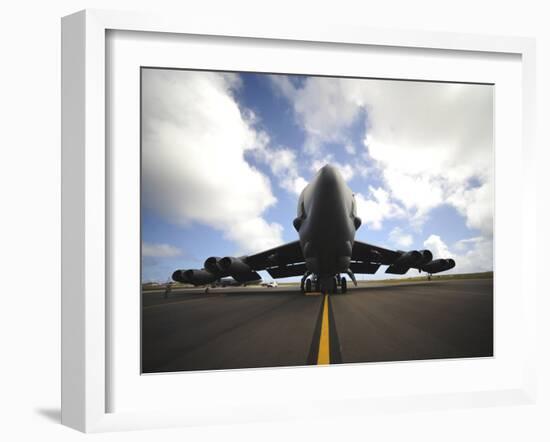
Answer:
62;11;536;432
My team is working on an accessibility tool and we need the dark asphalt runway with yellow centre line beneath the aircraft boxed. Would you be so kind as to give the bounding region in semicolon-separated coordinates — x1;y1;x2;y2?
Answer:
142;279;493;373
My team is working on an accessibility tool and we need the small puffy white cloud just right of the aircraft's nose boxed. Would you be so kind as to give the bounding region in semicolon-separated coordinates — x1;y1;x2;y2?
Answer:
355;186;405;230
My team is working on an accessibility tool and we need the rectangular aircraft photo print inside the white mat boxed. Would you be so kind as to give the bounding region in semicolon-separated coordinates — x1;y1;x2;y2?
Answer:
140;67;494;373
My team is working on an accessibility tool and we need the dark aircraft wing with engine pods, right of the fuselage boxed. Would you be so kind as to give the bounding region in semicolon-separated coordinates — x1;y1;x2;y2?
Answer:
350;241;455;275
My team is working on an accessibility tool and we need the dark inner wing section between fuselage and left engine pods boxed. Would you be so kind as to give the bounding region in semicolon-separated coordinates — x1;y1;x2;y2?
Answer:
245;241;306;278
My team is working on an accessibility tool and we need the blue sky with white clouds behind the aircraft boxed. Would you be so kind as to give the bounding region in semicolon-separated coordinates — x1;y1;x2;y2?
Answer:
141;68;494;282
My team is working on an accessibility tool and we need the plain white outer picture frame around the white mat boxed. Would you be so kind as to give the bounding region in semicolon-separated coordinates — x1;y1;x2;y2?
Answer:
62;10;537;432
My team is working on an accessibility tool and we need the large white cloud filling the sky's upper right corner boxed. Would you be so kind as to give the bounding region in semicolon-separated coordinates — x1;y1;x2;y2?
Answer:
365;82;493;234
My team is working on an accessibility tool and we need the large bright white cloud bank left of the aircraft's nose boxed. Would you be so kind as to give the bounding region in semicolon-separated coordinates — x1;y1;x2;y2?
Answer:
142;69;282;252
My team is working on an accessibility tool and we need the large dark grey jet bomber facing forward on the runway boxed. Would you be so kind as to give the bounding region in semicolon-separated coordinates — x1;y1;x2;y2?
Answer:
172;165;455;293
